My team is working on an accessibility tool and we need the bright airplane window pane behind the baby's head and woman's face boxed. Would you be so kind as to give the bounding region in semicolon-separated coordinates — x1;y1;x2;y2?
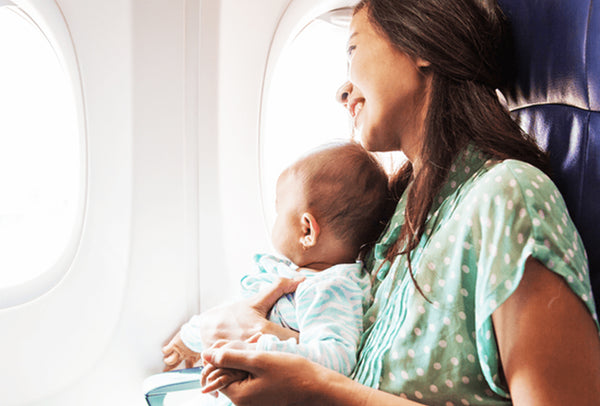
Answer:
261;19;351;228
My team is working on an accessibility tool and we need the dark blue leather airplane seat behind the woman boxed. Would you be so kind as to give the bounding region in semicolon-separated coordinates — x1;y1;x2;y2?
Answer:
499;0;600;309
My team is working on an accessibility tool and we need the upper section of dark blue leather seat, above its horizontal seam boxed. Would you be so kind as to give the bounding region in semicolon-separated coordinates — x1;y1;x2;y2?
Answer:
499;0;600;111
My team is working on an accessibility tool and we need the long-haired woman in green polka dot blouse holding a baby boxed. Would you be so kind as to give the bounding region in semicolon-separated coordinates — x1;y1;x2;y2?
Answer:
189;0;600;405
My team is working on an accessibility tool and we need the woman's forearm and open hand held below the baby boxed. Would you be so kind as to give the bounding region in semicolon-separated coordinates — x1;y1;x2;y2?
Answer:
203;349;419;406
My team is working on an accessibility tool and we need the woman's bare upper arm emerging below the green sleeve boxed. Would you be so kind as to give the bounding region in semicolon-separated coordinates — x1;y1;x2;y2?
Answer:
492;258;600;406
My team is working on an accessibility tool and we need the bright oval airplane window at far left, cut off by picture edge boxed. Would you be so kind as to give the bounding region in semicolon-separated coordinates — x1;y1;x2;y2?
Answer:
0;2;84;288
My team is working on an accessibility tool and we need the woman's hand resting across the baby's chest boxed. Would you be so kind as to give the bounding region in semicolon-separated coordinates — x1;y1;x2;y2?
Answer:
195;277;304;347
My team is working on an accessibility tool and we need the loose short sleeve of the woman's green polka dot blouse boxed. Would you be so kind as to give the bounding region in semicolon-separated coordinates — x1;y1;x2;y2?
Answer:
472;161;598;396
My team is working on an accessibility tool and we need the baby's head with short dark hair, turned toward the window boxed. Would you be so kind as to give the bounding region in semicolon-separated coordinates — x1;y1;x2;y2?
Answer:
272;142;391;269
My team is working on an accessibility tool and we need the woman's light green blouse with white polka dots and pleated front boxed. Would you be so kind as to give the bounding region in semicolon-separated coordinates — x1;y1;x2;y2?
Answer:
353;147;598;406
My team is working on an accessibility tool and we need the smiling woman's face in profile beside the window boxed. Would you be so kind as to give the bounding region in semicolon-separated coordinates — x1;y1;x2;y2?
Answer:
337;9;431;160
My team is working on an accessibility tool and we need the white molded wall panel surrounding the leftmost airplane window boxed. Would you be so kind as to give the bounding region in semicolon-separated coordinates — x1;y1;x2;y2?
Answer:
0;0;132;405
